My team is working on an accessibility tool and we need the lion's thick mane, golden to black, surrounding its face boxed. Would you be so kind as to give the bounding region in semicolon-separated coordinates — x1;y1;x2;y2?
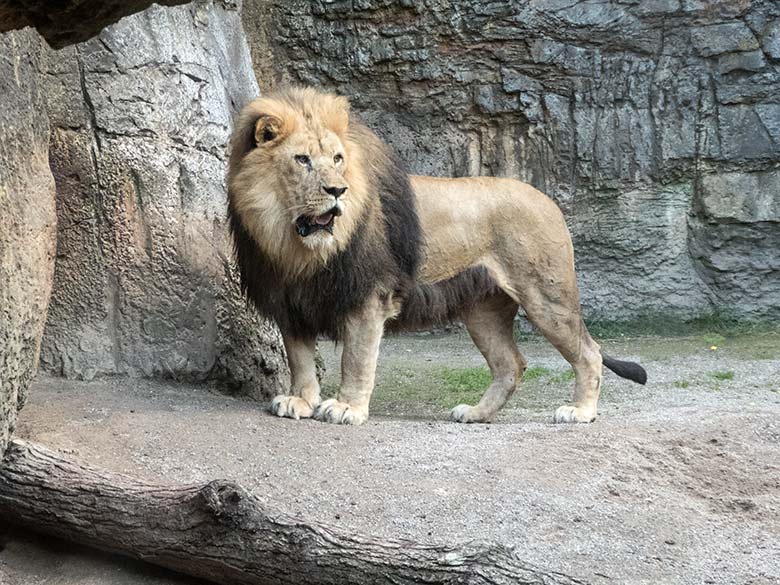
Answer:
228;89;422;340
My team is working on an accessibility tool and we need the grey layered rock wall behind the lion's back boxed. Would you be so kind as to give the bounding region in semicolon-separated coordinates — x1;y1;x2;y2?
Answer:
244;0;780;319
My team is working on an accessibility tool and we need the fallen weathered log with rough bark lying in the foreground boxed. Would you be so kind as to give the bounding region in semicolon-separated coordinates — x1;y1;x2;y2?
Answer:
0;440;578;585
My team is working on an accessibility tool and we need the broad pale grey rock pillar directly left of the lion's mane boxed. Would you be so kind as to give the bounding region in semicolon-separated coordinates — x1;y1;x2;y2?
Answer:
36;1;284;398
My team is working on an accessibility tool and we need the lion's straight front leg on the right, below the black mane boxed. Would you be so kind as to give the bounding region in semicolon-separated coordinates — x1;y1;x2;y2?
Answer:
314;297;389;425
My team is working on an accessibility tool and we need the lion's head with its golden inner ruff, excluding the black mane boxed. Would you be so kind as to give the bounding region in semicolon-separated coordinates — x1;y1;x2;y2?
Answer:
228;88;368;276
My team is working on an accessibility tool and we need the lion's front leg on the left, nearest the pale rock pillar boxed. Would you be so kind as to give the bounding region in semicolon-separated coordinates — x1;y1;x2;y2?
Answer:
271;332;320;420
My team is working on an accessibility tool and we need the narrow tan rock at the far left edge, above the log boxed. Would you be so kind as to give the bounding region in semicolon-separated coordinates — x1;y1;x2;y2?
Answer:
0;31;56;454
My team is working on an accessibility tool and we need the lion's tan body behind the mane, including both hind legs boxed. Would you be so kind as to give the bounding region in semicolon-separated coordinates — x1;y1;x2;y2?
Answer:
412;176;601;422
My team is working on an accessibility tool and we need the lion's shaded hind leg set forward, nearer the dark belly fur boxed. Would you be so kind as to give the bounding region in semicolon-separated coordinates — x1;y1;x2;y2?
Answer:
450;293;526;422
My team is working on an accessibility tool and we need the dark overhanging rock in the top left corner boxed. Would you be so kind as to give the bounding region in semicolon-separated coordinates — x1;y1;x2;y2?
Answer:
0;0;187;49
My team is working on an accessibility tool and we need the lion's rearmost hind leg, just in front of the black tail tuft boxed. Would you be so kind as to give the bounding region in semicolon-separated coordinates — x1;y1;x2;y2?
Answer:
523;288;602;422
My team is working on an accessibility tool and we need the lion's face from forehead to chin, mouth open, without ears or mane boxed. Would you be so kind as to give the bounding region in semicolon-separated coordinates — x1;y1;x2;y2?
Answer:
275;127;350;248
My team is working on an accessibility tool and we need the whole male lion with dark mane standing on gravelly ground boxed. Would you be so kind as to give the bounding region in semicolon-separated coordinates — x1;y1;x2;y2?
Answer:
228;88;646;424
